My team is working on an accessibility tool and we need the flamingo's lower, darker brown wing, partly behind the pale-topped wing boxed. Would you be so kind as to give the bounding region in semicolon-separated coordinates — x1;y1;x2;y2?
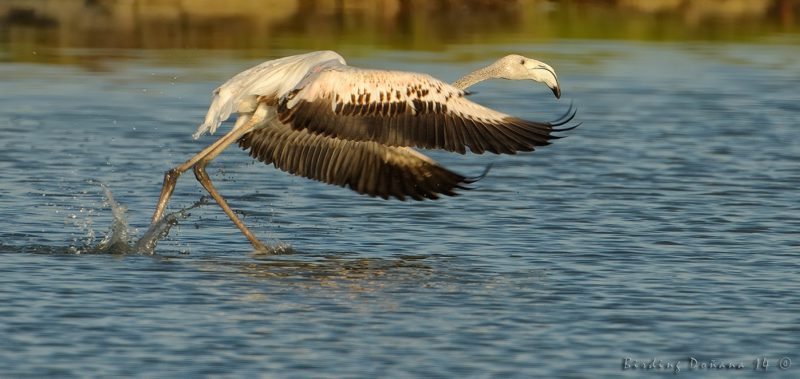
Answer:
234;121;475;200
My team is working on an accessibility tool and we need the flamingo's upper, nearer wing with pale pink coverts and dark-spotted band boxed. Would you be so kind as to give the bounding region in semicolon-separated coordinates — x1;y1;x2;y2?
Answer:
278;66;574;154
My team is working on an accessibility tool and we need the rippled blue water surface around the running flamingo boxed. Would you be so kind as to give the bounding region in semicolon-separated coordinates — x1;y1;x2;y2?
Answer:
0;41;800;378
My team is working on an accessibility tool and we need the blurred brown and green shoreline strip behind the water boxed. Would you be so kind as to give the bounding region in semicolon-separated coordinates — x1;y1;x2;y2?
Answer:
0;0;800;63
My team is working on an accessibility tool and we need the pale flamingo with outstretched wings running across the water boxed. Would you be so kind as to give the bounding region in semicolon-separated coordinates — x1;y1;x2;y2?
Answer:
152;51;578;251
